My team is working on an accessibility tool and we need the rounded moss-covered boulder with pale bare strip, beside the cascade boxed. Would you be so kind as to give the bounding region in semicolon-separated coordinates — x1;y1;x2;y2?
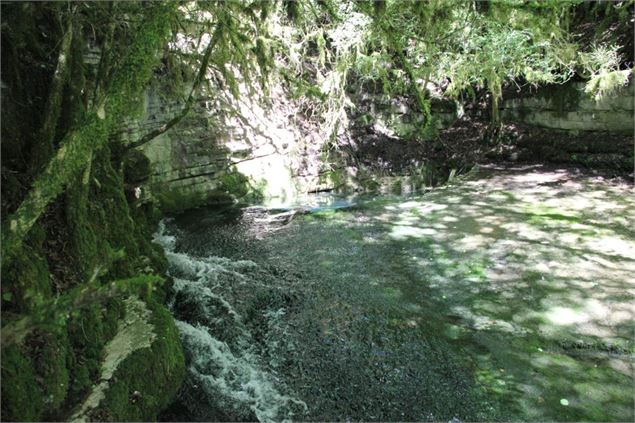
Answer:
73;297;185;421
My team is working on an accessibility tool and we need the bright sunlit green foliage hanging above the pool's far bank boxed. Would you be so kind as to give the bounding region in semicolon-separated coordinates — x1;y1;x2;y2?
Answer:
270;0;608;139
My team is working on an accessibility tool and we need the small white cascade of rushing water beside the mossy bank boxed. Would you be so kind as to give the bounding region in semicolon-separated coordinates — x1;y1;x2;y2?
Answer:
154;221;306;422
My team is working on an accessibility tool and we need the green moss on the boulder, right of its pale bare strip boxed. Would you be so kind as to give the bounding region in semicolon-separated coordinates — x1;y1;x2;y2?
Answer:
91;299;185;421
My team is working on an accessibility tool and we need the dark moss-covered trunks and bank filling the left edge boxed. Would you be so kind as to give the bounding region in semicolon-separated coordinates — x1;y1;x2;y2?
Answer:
1;2;190;421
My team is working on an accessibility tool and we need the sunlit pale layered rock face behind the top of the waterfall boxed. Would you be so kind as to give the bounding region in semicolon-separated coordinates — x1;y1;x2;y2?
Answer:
121;77;332;211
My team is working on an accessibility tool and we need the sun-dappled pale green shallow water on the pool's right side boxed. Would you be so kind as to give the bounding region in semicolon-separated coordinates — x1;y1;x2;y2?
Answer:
350;165;635;418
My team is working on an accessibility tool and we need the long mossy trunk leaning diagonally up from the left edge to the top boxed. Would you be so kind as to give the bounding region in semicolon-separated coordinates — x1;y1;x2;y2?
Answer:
2;3;174;263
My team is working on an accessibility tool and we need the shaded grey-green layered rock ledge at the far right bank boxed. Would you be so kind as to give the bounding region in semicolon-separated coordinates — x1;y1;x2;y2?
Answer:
501;80;635;175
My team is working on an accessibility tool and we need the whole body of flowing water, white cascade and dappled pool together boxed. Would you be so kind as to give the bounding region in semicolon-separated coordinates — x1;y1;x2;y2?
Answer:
155;169;635;421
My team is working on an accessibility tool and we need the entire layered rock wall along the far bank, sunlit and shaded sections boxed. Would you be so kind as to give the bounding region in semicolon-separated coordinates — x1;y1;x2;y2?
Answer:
121;76;633;211
